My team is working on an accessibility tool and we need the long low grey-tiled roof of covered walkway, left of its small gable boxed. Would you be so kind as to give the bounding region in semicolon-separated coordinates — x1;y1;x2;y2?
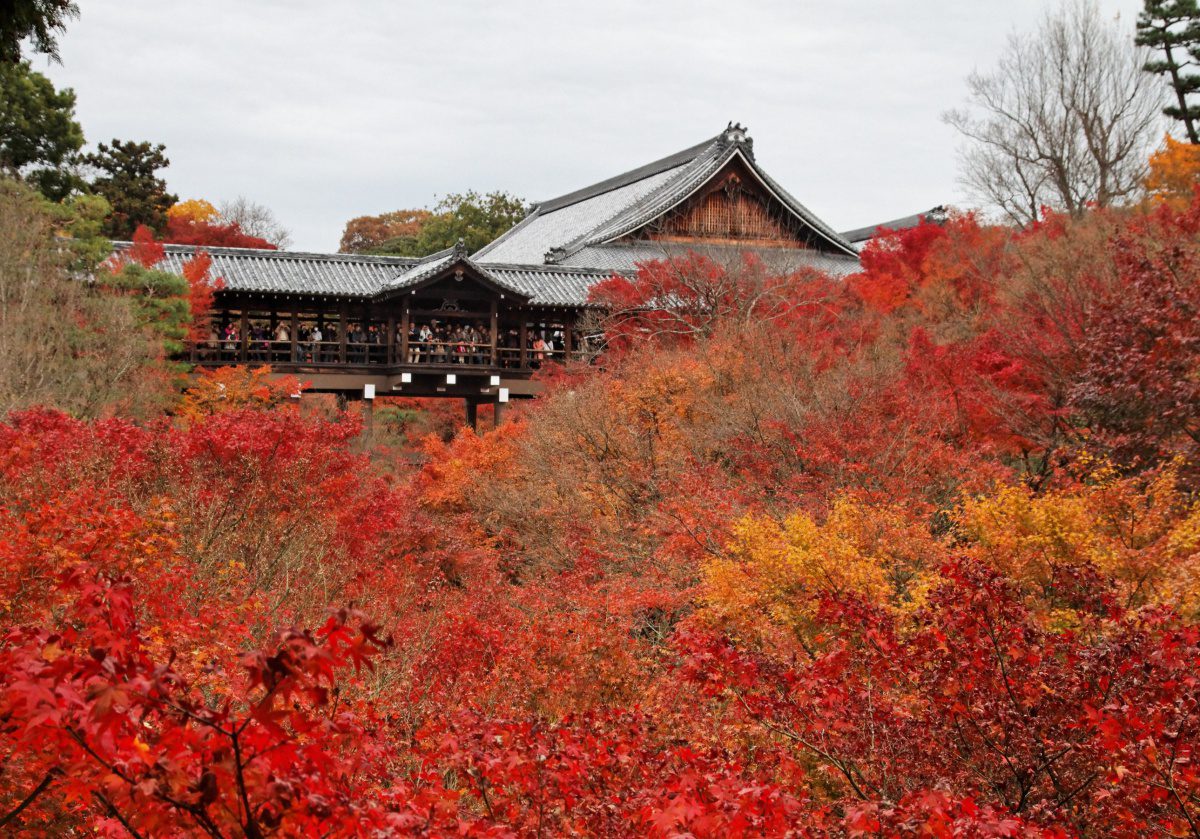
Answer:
113;241;420;296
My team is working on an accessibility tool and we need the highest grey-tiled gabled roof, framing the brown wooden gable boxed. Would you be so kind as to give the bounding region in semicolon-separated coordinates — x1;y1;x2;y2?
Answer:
475;125;854;264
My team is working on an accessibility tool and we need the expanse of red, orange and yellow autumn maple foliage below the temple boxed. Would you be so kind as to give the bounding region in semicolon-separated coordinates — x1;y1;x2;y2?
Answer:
0;188;1200;839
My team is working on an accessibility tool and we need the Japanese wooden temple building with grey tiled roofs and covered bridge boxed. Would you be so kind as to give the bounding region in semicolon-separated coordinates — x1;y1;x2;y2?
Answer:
129;124;858;418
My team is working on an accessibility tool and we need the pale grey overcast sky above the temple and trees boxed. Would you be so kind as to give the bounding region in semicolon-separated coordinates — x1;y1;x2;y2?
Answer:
35;0;1141;251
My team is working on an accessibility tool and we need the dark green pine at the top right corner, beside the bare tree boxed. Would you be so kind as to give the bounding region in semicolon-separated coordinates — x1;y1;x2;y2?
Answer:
1136;0;1200;144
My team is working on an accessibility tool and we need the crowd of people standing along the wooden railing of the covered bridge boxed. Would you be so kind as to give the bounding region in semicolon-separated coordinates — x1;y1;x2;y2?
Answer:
199;320;565;367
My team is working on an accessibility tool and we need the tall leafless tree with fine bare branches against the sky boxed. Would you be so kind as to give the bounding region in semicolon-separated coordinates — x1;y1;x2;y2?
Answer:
944;0;1164;224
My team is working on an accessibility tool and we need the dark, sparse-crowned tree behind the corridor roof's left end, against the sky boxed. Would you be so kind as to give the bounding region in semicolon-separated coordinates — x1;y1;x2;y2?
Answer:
84;139;179;239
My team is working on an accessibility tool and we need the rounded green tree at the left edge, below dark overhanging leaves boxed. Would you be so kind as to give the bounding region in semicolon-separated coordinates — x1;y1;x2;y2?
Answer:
0;61;83;200
